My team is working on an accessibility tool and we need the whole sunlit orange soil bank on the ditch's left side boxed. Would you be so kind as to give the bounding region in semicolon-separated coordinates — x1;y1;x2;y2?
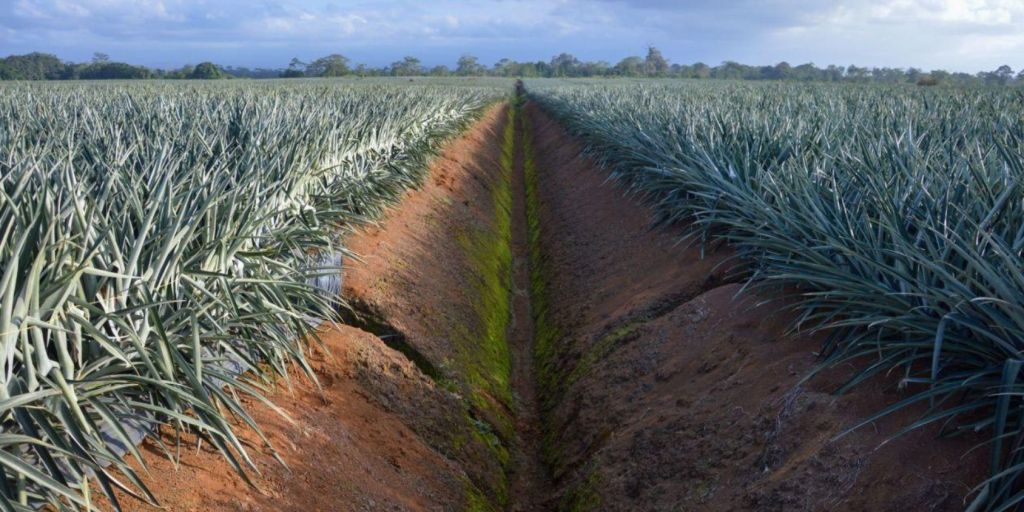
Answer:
112;106;512;511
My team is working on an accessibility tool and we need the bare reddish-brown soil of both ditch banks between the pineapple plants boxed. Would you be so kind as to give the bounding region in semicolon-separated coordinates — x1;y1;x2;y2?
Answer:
110;103;984;511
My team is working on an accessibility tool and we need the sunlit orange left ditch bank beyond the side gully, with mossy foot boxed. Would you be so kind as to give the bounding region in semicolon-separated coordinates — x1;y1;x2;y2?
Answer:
343;106;514;503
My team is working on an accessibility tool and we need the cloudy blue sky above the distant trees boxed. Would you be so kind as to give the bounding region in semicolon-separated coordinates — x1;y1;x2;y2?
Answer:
0;0;1024;73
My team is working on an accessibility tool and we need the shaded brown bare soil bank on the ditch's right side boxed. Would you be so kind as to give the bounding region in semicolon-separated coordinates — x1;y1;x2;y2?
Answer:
529;103;984;511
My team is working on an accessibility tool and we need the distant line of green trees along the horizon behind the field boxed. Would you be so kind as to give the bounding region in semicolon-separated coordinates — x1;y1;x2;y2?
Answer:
0;46;1024;85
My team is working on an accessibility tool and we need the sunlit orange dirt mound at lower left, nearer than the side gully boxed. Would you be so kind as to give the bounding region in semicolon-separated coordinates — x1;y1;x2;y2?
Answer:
107;326;465;511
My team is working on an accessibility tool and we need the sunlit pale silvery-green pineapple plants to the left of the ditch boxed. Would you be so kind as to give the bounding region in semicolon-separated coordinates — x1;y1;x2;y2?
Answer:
0;77;506;510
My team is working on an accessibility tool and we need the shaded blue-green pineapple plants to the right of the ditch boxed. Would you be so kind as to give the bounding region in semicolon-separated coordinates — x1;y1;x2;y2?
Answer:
527;77;1024;510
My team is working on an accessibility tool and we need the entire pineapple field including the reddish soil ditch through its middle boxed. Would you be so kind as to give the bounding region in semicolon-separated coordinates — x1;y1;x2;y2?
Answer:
0;78;1024;511
